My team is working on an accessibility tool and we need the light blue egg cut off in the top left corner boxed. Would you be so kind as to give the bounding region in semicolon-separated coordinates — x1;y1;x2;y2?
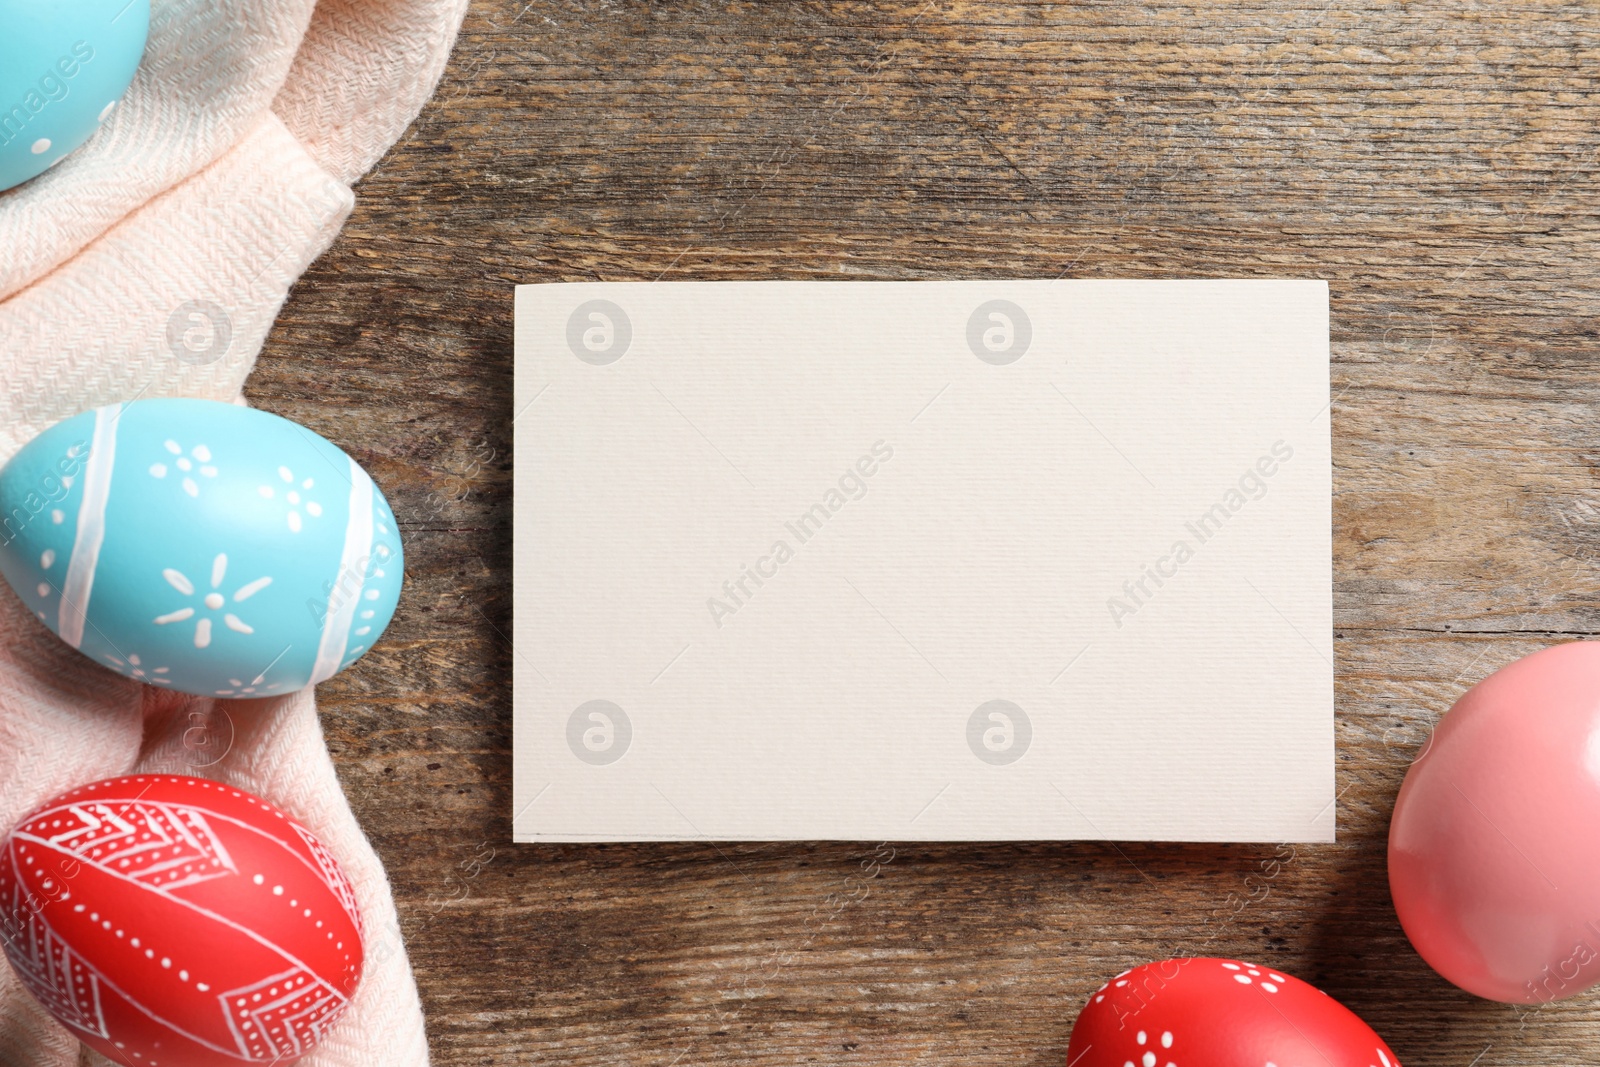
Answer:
0;0;150;190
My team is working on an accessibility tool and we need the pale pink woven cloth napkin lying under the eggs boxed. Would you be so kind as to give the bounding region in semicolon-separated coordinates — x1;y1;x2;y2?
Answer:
0;0;466;1067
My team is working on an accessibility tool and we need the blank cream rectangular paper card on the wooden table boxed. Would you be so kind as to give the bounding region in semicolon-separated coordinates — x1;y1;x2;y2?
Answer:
512;282;1334;841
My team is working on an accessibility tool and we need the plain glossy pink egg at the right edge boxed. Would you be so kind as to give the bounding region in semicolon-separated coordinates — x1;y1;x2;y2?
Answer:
1389;641;1600;1003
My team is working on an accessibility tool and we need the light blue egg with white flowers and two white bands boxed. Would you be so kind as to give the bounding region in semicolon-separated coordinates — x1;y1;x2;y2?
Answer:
0;400;405;697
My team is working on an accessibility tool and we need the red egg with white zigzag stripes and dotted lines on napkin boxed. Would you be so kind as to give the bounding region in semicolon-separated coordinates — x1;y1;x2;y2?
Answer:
0;774;362;1067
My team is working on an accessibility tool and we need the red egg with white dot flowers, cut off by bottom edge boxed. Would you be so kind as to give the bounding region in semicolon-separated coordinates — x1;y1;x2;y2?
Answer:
1067;958;1400;1067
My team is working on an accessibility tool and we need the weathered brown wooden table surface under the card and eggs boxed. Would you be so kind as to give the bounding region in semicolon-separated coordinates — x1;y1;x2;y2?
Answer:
250;0;1600;1067
